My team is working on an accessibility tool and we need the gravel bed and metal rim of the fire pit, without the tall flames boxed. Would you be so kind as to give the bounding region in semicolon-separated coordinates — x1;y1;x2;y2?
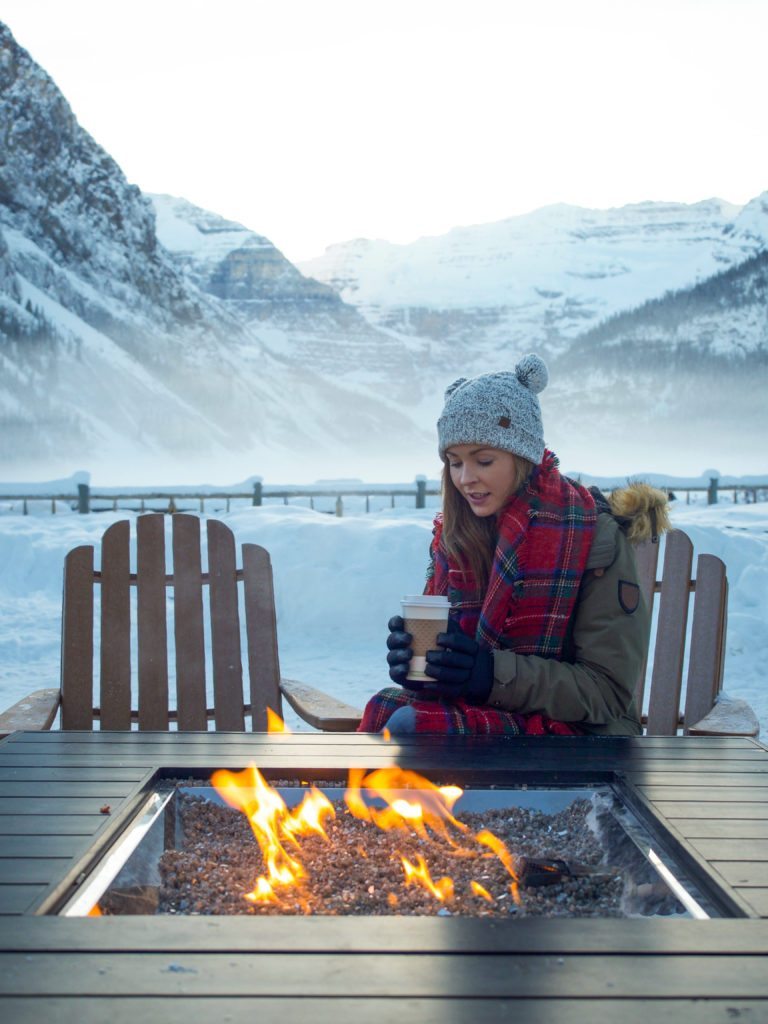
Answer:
62;780;717;918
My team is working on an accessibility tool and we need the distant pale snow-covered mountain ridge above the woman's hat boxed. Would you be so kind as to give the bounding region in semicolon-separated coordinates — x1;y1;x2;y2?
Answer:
301;193;768;372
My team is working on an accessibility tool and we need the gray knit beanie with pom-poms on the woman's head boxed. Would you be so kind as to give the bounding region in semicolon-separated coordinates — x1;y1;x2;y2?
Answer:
437;353;549;466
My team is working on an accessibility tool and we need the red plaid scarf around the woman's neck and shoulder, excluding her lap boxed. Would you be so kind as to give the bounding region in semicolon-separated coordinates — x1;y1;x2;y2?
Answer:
426;452;597;657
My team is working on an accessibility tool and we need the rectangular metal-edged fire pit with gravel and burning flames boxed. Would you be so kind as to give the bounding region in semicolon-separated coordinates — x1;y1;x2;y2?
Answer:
60;766;720;920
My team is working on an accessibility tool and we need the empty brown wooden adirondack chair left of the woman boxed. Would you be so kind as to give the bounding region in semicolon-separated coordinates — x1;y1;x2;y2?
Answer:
0;514;361;733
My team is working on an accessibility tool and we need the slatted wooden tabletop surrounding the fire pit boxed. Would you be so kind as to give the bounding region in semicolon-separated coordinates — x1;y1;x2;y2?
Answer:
0;732;768;1024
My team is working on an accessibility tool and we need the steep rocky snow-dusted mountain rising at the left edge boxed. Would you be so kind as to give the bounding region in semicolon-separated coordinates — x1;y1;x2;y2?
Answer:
0;26;428;475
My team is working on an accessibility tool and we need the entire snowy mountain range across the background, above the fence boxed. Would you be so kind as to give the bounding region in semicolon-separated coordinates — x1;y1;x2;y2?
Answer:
0;16;768;482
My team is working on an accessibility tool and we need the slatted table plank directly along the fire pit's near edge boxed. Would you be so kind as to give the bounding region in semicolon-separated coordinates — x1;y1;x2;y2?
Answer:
0;914;768;954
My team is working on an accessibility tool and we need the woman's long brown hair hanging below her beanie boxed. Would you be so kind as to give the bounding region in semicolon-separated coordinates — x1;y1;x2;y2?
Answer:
442;455;534;593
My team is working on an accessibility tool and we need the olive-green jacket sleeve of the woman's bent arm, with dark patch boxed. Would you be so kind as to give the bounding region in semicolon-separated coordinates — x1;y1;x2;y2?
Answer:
488;519;650;732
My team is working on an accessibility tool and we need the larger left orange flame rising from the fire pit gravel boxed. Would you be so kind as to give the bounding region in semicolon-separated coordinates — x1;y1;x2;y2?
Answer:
211;765;336;903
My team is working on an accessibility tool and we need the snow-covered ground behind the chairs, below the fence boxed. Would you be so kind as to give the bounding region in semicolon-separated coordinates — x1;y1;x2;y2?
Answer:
0;499;768;738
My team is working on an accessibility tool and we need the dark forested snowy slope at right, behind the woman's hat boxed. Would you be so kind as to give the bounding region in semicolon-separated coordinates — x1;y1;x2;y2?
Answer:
549;251;768;472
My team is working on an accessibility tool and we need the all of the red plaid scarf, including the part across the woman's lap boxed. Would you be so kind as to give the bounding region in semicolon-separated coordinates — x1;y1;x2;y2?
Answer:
358;452;597;736
